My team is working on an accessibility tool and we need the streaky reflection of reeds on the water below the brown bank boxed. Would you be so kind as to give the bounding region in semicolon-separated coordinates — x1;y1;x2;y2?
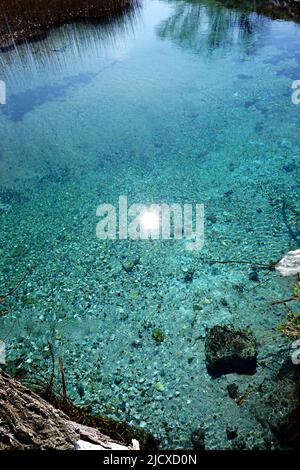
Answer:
0;0;141;98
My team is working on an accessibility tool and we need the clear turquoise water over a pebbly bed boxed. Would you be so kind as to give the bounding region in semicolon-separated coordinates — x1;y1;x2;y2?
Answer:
0;0;300;449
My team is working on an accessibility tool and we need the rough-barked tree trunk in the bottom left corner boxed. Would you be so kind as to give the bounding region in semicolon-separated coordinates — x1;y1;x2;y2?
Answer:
0;370;138;450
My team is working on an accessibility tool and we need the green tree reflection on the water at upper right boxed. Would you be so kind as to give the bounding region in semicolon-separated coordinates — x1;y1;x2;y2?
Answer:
157;0;269;56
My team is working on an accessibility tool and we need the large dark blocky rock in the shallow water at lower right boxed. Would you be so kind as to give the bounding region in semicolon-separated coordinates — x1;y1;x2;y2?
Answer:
205;325;257;377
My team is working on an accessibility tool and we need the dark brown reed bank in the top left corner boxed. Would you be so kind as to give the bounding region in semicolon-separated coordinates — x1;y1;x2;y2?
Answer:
0;0;138;50
